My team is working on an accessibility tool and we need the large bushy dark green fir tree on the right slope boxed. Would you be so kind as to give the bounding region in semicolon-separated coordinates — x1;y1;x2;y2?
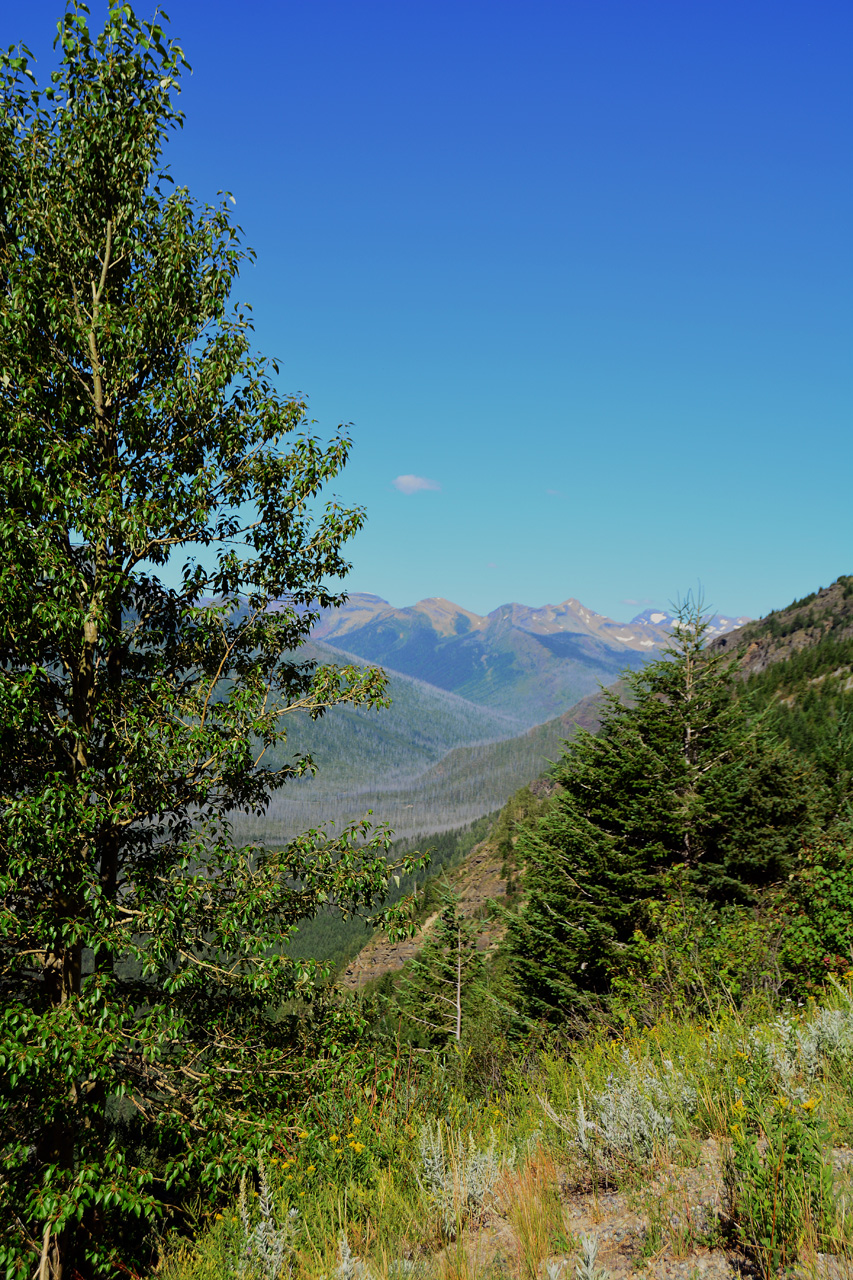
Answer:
506;596;813;1021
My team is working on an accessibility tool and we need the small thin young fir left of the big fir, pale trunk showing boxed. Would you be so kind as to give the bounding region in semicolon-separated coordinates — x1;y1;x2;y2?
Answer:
400;884;483;1048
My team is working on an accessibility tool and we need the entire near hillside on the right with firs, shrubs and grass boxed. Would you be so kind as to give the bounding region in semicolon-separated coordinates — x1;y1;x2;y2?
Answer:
158;580;853;1280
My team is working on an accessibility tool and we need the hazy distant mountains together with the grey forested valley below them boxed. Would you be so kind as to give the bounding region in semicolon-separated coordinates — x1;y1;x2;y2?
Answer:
234;594;747;844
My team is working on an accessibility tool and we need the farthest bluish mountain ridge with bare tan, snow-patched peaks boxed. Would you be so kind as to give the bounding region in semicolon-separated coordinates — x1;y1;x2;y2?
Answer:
313;594;743;728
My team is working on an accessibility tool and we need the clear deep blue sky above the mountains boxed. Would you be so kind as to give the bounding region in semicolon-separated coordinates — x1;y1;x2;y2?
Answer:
14;0;853;618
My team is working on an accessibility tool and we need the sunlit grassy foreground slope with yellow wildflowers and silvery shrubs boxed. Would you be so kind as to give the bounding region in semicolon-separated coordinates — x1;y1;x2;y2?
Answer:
156;988;853;1280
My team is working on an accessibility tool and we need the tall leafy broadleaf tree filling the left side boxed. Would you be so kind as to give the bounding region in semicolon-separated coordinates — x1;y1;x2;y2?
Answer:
0;4;414;1280
